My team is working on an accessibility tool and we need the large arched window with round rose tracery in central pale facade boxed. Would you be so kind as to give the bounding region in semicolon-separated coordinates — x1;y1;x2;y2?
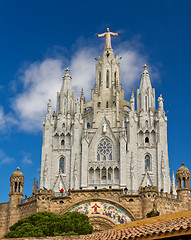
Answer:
97;138;113;160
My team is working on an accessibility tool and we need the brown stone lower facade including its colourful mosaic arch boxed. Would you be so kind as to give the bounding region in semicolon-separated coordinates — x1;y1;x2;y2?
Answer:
0;171;191;237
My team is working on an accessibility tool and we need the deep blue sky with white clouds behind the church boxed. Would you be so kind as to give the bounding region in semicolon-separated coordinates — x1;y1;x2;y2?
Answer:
0;0;191;202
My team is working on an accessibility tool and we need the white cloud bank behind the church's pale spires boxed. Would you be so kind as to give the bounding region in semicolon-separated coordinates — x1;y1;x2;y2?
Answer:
11;37;160;132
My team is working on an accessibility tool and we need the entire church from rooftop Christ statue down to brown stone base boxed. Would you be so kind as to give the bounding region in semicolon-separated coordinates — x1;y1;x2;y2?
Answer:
0;29;191;237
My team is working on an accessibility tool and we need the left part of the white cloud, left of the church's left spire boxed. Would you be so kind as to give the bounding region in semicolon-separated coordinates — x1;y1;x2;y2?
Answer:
13;58;64;131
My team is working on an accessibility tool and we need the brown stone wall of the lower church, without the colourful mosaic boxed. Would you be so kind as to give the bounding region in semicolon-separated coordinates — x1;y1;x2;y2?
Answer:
0;187;191;237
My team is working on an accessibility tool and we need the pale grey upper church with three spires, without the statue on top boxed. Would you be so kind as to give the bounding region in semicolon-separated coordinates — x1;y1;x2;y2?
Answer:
40;29;171;193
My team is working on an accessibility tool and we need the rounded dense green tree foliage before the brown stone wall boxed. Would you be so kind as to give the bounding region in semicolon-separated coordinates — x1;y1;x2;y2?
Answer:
4;212;93;238
